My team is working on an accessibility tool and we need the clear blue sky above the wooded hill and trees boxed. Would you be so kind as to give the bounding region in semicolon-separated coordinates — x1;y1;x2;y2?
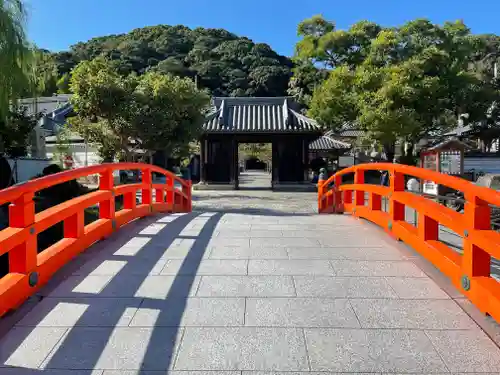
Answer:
27;0;500;55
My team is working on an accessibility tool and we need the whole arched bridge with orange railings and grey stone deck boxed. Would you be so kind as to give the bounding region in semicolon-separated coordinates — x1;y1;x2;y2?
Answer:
0;163;500;375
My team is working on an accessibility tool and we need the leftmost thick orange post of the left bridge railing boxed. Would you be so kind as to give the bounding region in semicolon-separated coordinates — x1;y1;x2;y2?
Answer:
9;192;37;274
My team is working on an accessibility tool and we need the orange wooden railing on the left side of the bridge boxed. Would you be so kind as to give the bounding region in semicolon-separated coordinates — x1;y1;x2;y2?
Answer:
0;163;192;317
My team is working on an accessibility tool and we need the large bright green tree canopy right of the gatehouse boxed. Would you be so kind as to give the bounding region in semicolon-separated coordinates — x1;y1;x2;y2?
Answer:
296;16;499;157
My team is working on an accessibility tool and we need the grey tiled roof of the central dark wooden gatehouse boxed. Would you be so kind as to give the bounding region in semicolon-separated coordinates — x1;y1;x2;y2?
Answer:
203;97;320;133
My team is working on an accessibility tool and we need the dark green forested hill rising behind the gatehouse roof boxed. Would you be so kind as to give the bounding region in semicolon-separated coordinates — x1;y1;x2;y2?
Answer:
44;25;292;96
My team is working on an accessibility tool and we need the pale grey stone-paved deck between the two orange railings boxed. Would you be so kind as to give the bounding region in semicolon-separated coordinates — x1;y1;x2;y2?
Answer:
0;191;500;375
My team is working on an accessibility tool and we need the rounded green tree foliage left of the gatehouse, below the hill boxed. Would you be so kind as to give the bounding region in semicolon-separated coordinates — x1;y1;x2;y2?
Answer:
70;57;209;161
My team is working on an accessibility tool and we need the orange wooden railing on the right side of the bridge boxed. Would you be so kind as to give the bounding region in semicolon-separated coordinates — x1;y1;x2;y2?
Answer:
318;163;500;322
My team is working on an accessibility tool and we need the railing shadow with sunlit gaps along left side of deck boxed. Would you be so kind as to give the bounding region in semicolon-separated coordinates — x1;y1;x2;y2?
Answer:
0;212;223;375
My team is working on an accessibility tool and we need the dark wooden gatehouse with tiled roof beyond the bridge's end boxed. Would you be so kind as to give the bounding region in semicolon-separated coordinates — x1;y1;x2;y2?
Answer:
200;97;323;189
